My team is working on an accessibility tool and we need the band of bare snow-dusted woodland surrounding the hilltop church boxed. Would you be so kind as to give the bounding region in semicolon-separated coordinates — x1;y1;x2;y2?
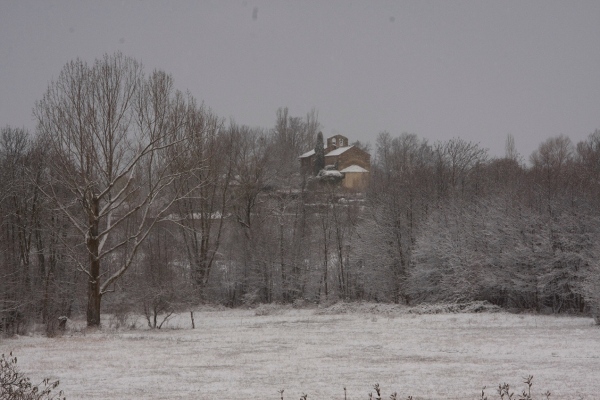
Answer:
0;53;600;334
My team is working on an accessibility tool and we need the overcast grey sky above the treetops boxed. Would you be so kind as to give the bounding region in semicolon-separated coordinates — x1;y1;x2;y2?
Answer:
0;0;600;158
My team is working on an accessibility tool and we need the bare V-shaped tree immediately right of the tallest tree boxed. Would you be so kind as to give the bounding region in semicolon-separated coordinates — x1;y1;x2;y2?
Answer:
174;102;236;298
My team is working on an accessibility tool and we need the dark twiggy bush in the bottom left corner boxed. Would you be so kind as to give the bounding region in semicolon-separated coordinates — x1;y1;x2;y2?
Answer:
0;353;65;400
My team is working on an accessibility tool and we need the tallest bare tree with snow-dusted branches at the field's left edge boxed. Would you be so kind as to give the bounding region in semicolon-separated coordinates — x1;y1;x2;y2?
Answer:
34;53;192;326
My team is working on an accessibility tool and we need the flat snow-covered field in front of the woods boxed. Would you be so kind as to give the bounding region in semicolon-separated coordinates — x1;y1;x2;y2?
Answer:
0;307;600;400
